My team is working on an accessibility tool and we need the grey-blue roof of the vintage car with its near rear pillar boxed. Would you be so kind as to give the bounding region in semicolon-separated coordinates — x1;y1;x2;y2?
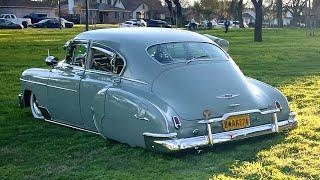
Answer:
74;27;214;83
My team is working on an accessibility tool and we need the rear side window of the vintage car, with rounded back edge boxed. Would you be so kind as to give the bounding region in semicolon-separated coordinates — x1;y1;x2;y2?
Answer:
90;47;124;74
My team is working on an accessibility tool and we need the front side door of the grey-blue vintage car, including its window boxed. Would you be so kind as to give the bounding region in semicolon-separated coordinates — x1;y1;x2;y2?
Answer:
48;42;88;127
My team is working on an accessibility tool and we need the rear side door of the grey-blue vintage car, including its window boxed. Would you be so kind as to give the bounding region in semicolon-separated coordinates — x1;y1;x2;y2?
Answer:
80;43;124;131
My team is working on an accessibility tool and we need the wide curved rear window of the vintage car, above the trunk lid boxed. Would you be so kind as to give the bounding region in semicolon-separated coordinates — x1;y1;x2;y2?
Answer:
147;42;228;64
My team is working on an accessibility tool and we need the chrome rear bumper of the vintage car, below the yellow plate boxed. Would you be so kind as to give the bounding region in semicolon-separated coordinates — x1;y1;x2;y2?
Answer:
144;113;297;152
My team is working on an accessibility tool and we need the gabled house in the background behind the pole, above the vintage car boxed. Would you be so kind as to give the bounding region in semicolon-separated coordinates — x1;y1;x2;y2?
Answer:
63;0;167;24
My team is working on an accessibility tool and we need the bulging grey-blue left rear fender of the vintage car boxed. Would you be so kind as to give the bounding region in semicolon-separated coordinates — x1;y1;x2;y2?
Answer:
98;82;178;147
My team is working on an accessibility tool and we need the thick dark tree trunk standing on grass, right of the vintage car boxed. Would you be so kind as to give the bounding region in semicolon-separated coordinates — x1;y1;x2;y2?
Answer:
251;0;263;42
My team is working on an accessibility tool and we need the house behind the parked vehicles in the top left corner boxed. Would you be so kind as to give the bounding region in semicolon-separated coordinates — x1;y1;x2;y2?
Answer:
0;0;57;17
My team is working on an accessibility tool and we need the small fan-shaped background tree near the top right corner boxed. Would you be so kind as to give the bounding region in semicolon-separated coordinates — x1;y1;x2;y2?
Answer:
285;0;306;26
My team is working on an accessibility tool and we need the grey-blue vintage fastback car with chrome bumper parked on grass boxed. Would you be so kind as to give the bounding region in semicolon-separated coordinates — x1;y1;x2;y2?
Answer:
19;28;297;152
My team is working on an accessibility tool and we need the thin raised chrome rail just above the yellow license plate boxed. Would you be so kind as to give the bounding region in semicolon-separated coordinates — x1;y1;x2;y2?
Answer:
198;109;280;124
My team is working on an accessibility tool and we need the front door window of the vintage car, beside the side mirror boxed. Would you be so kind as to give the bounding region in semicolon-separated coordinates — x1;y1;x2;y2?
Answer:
65;44;87;67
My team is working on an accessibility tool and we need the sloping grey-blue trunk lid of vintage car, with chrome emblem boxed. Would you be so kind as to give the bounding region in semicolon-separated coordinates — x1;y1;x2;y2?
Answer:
152;61;272;120
